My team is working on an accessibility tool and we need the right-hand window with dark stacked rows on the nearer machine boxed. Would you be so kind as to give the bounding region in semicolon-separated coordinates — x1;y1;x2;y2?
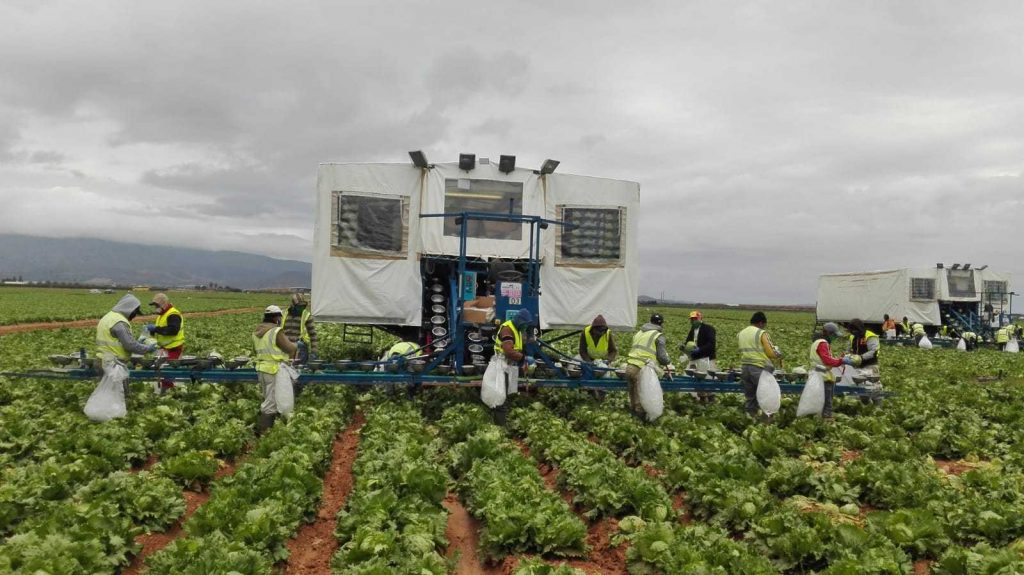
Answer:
556;206;626;266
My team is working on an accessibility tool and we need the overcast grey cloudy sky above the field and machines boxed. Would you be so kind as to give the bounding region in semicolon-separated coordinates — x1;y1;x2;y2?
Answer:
0;0;1024;303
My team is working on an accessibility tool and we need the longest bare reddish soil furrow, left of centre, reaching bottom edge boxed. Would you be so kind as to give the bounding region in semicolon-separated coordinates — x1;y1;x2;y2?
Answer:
284;413;365;575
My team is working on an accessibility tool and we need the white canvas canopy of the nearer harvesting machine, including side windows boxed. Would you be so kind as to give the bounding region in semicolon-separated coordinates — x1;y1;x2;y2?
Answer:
312;163;640;329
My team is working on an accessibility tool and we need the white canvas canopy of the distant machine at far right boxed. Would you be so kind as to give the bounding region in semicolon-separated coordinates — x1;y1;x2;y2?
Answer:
817;268;1010;325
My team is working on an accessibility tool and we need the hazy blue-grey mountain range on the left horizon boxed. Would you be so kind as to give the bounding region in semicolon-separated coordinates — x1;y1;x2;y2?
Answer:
0;234;312;290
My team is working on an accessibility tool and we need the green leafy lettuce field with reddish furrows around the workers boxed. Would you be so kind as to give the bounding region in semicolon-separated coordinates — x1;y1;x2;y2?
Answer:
0;291;1024;575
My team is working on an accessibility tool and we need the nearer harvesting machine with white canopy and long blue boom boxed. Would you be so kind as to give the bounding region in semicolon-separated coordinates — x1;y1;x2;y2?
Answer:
14;152;879;395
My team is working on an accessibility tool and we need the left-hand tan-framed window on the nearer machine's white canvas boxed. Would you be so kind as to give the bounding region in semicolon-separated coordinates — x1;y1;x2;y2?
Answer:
331;191;409;257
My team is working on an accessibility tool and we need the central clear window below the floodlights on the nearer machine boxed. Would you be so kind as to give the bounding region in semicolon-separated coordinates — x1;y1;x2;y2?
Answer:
444;178;523;240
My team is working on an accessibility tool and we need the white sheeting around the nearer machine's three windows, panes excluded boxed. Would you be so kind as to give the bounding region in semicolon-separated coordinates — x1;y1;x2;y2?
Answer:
311;163;640;329
